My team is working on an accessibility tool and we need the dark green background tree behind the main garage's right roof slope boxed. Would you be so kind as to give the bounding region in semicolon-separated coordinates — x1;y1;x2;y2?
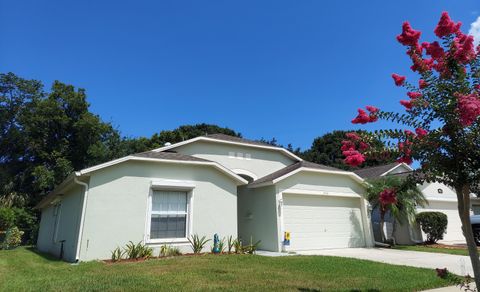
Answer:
301;131;395;170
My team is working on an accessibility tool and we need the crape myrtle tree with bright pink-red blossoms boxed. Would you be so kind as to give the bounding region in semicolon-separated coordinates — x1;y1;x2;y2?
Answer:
342;12;480;287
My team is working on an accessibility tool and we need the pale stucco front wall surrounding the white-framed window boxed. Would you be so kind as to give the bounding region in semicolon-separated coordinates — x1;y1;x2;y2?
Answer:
80;161;237;260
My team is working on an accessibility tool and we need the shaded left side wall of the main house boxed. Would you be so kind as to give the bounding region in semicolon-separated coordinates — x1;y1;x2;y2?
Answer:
37;185;84;262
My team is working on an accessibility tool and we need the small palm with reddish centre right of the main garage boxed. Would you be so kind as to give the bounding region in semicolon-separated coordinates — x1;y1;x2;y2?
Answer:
365;176;427;242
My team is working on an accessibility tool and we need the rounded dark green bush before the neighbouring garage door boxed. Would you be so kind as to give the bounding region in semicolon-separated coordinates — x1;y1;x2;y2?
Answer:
415;212;448;244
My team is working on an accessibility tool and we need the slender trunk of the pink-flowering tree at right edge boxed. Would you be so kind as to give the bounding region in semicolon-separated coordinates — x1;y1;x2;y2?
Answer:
455;185;480;287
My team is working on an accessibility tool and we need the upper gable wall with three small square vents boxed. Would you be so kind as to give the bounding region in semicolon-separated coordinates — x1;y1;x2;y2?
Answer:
171;141;295;179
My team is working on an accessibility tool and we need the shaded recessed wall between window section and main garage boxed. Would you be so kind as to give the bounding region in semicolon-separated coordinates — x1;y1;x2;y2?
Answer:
238;186;278;251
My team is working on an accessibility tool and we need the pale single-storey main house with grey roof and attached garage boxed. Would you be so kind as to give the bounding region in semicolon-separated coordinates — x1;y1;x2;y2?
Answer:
37;134;373;262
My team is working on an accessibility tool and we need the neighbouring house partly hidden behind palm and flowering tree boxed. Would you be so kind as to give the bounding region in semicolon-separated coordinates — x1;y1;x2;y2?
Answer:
355;162;474;244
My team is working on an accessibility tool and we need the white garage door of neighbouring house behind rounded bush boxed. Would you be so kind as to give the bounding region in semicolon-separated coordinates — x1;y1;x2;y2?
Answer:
418;201;465;241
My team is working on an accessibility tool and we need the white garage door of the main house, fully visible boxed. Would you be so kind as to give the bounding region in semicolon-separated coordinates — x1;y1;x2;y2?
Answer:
283;194;365;250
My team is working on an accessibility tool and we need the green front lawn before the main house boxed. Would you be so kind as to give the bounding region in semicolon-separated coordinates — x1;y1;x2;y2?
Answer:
0;248;449;292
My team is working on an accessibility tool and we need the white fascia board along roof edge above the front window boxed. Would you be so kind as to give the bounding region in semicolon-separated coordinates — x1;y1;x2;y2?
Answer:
78;155;248;185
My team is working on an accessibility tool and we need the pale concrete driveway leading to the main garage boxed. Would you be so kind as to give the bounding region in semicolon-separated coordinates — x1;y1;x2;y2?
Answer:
297;248;473;275
